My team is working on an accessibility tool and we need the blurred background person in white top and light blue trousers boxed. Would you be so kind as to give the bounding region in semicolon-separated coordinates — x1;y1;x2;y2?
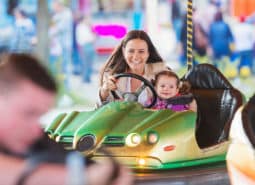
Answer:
76;16;96;83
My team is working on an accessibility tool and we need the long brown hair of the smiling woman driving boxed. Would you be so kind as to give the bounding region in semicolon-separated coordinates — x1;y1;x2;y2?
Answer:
100;30;163;83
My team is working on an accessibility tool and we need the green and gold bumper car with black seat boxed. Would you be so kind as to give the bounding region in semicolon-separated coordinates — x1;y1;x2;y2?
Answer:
45;64;244;169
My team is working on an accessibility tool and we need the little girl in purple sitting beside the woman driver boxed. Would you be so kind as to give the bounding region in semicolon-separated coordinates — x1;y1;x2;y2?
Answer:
150;71;196;111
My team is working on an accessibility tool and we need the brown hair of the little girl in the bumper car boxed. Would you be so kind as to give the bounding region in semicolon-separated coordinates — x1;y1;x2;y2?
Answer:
152;70;191;94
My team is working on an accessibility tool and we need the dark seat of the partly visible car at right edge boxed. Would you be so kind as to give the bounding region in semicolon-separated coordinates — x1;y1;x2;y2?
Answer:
242;94;255;148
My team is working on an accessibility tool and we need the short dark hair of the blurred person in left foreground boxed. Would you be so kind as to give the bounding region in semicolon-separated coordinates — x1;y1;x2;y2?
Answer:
0;53;57;93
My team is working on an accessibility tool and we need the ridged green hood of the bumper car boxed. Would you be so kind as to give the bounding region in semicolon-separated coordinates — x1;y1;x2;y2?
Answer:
74;102;196;146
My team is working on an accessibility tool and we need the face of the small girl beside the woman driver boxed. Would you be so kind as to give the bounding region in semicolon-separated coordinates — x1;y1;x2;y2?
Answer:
155;75;179;99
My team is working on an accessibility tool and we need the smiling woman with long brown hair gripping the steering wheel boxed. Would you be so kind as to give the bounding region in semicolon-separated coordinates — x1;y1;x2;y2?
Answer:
99;30;167;103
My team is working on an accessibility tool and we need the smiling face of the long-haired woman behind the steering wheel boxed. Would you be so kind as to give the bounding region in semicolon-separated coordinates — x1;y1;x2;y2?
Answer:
122;39;149;75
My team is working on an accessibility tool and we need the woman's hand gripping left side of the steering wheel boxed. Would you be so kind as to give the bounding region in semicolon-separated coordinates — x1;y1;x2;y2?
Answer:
100;76;117;101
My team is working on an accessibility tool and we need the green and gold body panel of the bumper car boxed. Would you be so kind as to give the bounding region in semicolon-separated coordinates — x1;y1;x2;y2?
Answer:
45;101;228;169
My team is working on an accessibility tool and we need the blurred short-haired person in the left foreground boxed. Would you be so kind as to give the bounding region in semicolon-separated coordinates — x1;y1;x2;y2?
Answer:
0;53;133;185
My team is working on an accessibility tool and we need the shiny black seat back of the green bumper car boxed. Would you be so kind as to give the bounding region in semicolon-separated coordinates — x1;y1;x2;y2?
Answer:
182;64;243;148
